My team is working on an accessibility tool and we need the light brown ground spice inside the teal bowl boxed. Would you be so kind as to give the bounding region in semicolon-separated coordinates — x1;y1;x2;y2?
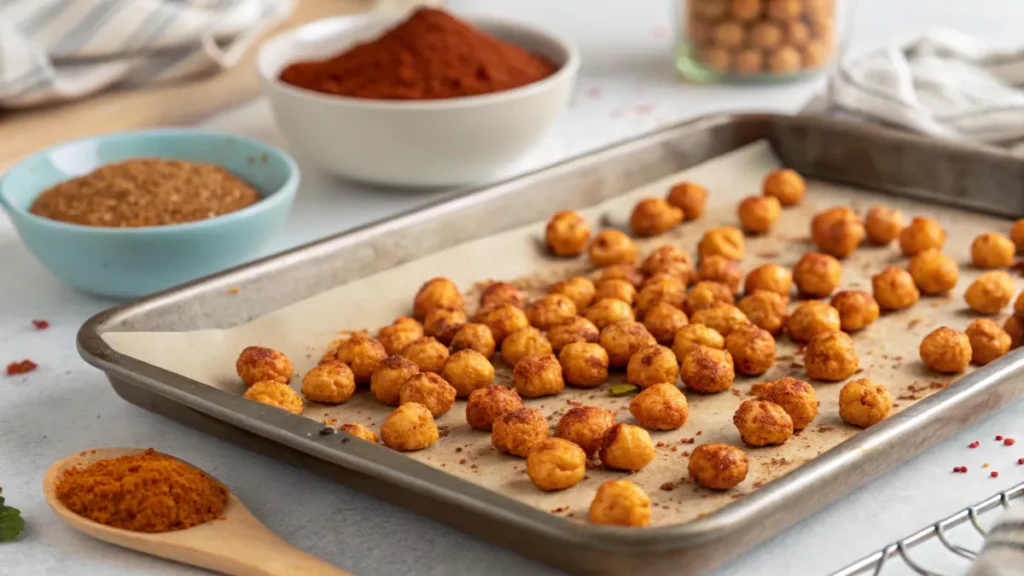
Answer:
30;158;262;228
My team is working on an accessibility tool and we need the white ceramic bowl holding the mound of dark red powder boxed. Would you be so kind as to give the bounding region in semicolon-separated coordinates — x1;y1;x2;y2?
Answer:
256;16;580;187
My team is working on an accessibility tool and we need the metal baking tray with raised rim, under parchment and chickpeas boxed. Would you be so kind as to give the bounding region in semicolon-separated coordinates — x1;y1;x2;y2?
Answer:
78;115;1024;574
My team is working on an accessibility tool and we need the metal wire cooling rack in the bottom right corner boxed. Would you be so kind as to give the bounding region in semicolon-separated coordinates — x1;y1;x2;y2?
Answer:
833;483;1024;576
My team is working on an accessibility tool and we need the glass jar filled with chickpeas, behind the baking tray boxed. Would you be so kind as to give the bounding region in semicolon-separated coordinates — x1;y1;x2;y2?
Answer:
675;0;845;82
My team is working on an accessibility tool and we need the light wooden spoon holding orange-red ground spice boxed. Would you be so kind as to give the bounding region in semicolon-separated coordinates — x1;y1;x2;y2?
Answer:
43;448;351;576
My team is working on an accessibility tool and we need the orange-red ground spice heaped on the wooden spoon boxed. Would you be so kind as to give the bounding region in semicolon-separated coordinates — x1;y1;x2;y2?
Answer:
56;449;227;532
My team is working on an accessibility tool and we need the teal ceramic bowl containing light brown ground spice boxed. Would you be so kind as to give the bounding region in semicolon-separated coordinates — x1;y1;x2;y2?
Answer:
0;128;299;298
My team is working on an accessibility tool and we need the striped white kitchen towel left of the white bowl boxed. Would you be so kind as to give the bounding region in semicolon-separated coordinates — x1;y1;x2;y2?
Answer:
0;0;293;108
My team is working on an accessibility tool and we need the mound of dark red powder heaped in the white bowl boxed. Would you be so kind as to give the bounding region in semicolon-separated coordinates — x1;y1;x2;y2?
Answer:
281;8;555;100
